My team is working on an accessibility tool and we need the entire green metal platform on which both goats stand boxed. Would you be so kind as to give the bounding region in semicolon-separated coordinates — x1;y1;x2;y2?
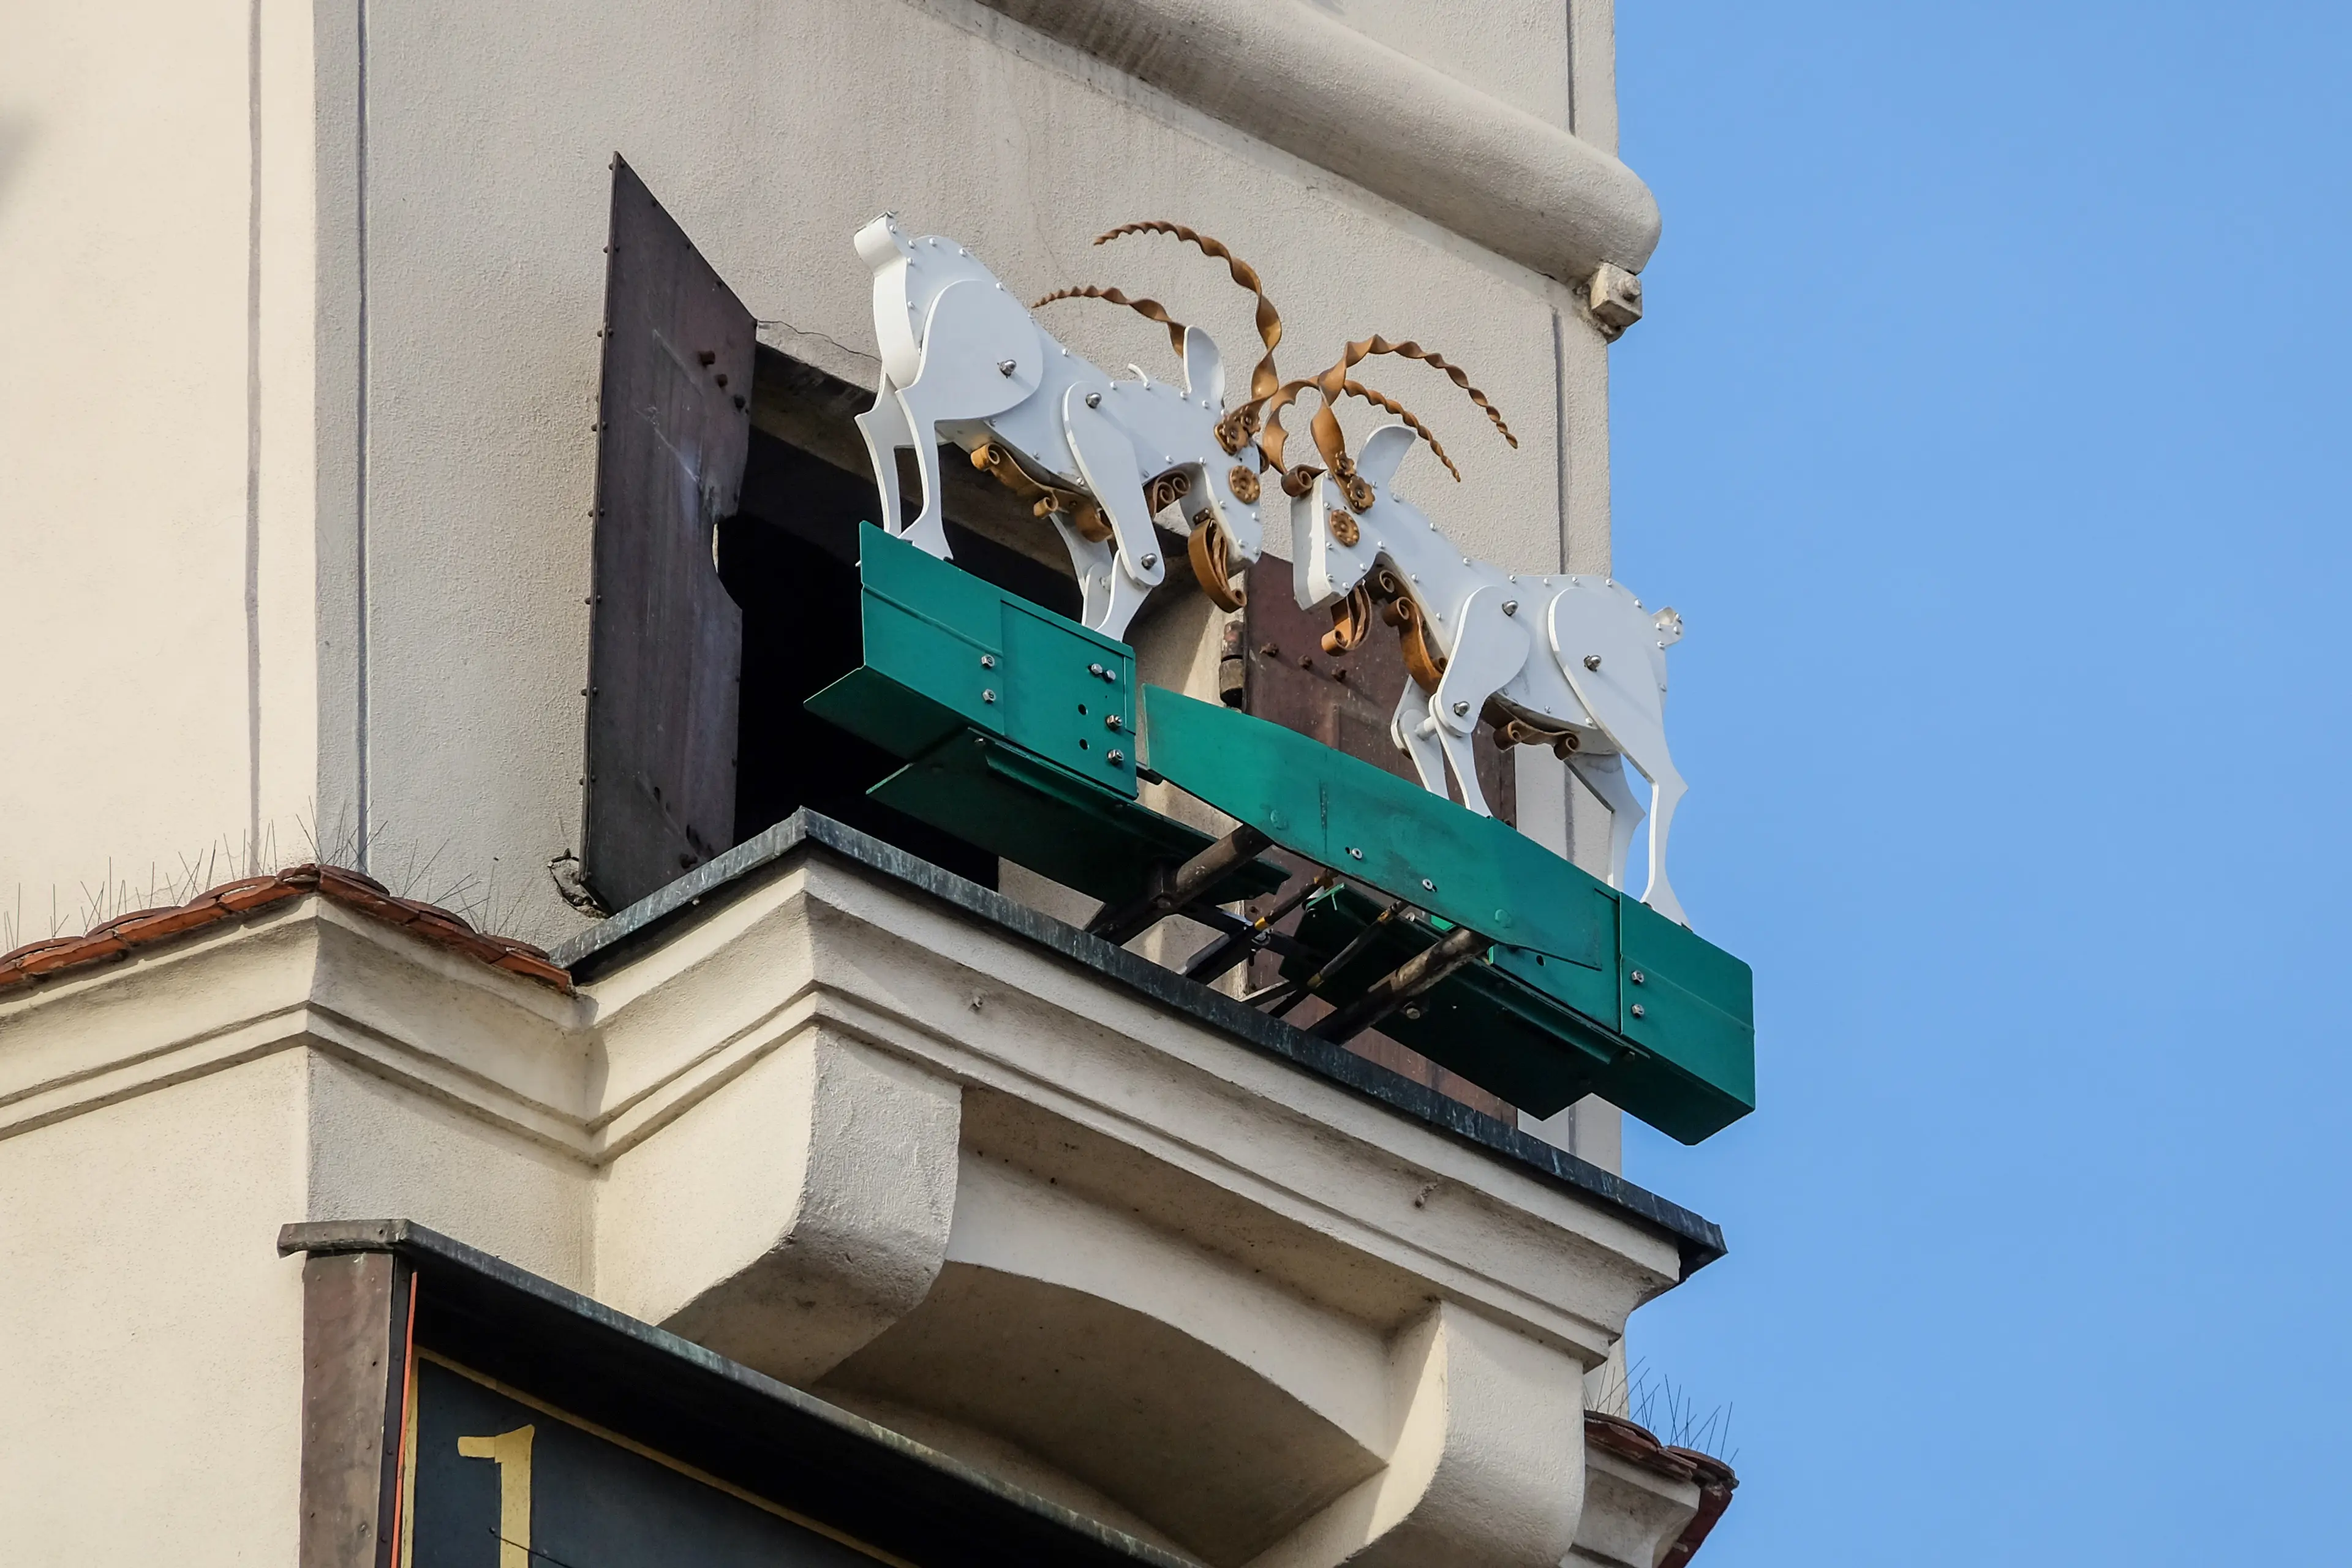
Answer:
809;524;1755;1142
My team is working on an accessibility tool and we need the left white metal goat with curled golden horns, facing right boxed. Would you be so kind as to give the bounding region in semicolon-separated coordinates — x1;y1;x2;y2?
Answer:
856;214;1282;637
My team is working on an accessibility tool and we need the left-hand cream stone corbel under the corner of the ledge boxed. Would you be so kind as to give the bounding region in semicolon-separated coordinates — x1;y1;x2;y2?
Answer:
595;1030;962;1385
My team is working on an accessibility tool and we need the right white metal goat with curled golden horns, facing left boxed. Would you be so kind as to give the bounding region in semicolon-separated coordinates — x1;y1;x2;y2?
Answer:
1258;336;1689;924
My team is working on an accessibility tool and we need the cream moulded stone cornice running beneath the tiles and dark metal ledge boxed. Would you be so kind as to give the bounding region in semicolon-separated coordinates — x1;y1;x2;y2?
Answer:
0;844;1712;1363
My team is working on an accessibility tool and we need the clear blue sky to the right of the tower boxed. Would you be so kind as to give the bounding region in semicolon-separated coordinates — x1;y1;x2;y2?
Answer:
1613;0;2352;1568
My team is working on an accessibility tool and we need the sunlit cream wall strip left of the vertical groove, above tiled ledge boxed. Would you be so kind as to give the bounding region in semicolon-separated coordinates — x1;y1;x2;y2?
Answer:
0;0;252;940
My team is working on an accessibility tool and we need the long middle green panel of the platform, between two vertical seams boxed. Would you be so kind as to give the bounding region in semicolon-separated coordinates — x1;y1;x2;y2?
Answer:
1143;687;1618;968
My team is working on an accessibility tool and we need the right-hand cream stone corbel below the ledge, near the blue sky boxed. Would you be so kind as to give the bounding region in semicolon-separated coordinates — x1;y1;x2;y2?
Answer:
1251;1302;1585;1568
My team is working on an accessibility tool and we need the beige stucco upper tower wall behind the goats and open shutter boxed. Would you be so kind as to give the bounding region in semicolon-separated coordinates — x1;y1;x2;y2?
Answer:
0;0;1646;987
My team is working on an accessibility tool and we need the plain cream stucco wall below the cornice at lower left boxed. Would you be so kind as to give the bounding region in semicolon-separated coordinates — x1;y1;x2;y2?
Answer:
0;1053;303;1566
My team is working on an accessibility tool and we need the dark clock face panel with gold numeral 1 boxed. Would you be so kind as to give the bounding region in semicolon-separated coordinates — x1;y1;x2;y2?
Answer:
402;1352;899;1568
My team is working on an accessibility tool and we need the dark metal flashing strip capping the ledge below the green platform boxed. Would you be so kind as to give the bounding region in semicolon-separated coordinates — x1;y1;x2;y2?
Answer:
551;811;1727;1279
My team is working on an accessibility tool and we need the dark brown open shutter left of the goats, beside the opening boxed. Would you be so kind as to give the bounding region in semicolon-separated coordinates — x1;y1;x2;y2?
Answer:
581;157;755;910
